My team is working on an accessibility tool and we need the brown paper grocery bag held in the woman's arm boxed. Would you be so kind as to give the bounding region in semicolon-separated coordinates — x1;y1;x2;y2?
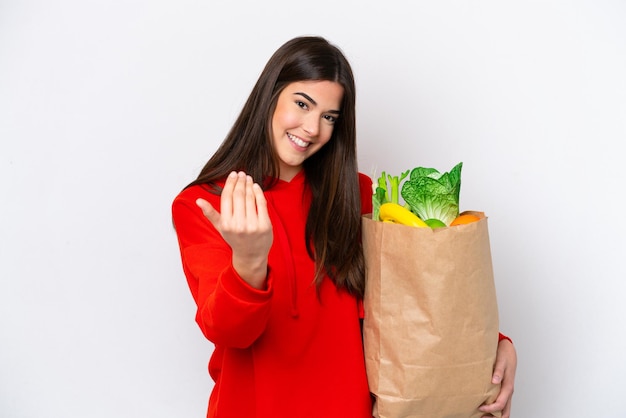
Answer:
362;212;500;418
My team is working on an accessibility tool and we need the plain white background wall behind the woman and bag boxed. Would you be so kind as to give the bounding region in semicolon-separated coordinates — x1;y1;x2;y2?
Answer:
0;0;626;418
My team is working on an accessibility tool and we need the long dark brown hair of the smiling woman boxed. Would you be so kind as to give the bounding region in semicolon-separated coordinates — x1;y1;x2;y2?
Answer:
187;36;365;297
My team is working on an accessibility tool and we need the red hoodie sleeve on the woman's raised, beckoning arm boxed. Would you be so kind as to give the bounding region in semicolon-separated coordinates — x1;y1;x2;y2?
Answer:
172;186;272;348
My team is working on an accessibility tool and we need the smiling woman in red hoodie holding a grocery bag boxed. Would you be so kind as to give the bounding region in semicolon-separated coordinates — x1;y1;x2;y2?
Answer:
172;37;515;418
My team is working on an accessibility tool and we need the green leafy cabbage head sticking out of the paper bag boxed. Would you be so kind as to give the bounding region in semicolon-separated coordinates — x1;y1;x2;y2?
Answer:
401;162;463;225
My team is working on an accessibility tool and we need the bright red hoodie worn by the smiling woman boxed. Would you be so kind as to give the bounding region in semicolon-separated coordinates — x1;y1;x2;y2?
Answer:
172;172;372;418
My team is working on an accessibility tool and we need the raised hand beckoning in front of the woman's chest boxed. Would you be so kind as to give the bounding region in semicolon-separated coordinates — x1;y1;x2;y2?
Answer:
196;171;273;289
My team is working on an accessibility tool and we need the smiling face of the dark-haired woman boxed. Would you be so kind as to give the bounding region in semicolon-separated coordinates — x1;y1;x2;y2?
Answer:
272;81;343;181
